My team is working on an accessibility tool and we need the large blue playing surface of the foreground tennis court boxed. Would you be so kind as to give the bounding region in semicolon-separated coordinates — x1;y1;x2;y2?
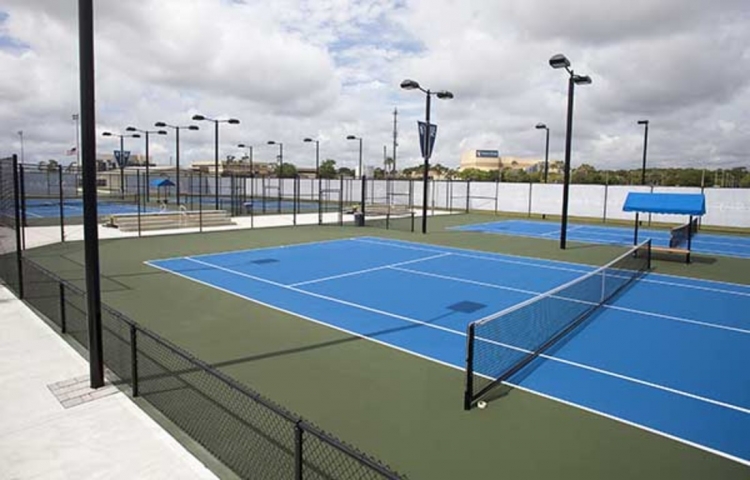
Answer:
147;237;750;465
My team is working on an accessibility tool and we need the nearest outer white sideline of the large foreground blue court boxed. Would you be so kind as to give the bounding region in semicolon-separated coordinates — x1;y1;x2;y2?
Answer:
144;262;750;465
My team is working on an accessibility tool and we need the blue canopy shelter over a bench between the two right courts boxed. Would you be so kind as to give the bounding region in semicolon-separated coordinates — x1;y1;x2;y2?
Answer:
622;192;706;263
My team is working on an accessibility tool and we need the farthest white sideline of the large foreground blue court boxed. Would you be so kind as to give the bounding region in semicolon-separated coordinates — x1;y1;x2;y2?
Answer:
352;238;750;297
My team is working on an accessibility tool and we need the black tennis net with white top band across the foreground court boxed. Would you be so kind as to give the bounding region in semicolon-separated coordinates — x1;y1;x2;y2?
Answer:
464;240;651;410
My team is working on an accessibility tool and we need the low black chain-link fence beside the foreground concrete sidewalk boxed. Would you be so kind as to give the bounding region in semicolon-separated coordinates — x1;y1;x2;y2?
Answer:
0;253;406;480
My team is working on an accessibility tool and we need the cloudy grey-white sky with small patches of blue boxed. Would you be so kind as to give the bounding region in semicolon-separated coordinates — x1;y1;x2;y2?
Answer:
0;0;750;172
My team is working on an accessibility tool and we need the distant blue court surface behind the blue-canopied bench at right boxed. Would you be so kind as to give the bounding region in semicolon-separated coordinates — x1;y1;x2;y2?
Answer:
454;220;750;258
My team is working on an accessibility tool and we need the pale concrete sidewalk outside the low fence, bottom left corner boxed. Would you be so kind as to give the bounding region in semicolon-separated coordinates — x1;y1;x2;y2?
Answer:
0;287;216;480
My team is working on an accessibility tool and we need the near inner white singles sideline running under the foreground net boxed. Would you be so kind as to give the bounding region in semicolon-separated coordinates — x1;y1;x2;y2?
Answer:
175;257;750;414
